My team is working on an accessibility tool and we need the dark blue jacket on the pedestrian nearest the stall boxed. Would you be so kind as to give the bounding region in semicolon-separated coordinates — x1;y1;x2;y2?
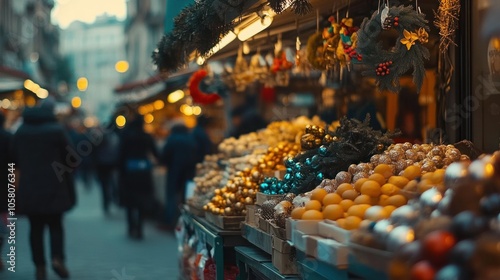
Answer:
161;125;196;195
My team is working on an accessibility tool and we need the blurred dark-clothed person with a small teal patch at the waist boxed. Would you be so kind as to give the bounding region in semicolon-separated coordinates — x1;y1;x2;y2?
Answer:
118;116;159;239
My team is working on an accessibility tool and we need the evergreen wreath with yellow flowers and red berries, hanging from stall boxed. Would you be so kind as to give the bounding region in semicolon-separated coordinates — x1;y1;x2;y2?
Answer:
357;6;430;92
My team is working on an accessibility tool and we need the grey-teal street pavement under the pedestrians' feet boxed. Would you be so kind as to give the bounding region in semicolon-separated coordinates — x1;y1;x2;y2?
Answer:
0;180;179;280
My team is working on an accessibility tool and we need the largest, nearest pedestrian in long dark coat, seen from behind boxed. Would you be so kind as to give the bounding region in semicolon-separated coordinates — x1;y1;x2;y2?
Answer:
12;101;76;279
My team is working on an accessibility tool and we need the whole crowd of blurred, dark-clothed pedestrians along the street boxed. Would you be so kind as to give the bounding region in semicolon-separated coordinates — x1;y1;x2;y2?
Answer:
0;98;213;280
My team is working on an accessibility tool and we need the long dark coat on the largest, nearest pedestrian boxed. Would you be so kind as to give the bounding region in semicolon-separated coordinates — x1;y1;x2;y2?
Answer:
12;107;76;215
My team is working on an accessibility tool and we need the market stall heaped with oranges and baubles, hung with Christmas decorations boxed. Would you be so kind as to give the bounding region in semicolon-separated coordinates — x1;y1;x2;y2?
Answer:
148;0;500;279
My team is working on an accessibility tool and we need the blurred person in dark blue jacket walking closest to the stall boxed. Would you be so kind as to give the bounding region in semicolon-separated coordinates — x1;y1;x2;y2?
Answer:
161;124;196;230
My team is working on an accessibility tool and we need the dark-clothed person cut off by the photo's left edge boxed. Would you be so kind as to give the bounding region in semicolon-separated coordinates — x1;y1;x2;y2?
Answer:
0;112;15;271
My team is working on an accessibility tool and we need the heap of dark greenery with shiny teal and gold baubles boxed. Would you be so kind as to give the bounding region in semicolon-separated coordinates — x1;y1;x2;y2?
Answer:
261;118;392;194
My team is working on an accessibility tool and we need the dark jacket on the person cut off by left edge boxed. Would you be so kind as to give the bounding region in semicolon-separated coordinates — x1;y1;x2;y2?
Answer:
0;127;12;213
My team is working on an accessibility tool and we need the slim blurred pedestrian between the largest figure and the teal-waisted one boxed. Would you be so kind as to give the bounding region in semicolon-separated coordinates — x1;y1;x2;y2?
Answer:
94;122;120;214
